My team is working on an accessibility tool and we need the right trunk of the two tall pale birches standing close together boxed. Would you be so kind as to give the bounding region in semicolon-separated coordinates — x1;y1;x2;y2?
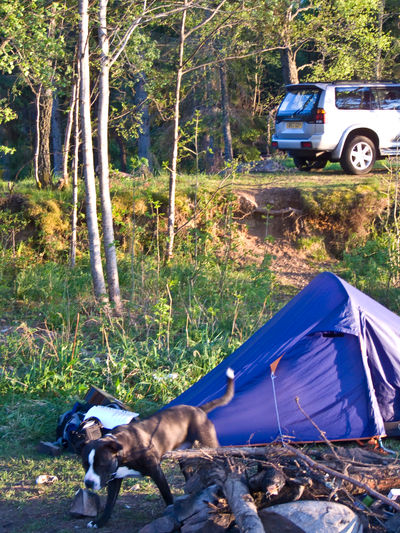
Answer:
98;0;122;314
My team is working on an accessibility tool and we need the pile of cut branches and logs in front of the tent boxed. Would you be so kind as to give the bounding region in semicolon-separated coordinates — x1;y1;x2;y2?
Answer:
154;444;400;533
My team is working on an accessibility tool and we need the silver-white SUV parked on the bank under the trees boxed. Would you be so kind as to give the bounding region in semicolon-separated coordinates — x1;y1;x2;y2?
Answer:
272;82;400;174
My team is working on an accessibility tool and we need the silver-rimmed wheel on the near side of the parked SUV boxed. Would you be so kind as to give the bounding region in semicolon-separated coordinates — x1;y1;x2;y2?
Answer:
340;136;376;175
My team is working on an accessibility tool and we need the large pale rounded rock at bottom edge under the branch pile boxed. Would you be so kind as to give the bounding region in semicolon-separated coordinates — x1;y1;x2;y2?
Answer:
259;500;363;533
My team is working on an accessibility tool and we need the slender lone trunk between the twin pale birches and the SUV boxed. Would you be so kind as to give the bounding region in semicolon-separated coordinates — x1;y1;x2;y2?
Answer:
167;0;188;259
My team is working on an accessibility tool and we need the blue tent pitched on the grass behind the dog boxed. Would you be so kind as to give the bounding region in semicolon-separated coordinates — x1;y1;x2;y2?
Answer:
165;272;400;445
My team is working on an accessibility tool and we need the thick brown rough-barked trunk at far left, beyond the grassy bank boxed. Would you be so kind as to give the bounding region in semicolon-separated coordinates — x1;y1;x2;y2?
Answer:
37;88;53;188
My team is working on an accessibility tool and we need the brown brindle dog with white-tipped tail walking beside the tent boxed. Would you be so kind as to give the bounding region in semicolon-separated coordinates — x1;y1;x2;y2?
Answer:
82;368;234;528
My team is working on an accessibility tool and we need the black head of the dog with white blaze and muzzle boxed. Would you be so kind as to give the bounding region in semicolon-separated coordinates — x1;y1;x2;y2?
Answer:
81;435;122;490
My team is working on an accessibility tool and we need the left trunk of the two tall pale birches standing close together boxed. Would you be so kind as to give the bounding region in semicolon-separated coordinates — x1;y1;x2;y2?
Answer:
79;0;107;302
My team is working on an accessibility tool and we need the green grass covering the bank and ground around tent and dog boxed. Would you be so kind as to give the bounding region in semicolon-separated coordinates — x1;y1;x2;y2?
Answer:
0;162;400;533
